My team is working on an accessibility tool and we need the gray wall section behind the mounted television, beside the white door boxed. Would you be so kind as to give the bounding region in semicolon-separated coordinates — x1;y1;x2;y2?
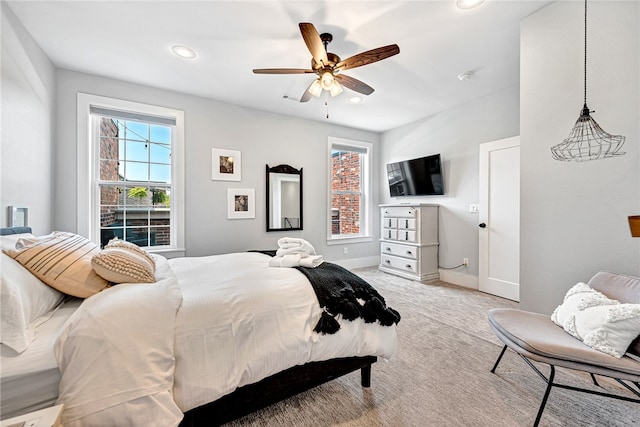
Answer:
378;82;520;288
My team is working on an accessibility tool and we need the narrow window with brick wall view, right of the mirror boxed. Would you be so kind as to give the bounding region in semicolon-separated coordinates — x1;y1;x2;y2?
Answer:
327;138;371;244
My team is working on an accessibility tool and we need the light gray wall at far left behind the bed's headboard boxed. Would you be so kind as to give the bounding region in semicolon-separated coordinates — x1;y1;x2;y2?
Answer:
0;2;56;234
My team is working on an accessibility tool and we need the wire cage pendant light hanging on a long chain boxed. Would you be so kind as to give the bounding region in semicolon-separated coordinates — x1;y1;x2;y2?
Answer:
551;0;625;162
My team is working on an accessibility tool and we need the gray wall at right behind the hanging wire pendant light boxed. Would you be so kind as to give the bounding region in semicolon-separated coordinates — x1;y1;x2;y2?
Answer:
520;2;640;313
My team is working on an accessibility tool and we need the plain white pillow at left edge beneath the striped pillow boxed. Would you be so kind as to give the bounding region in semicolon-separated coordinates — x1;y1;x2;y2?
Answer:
0;251;64;353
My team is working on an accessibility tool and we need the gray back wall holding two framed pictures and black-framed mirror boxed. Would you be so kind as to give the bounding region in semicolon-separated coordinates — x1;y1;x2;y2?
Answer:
54;70;379;260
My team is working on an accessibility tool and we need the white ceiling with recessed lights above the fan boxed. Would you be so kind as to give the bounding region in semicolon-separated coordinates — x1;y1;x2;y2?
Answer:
7;0;551;132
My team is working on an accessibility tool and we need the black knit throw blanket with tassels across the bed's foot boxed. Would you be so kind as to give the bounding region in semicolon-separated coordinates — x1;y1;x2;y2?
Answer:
294;261;400;334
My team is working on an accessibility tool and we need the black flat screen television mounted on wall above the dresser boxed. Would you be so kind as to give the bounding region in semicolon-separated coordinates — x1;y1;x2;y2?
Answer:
387;154;444;197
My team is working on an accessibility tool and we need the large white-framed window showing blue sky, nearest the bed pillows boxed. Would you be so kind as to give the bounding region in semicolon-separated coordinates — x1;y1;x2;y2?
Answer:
78;94;184;251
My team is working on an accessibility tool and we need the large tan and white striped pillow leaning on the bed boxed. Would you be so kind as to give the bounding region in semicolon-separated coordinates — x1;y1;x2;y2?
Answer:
5;231;109;298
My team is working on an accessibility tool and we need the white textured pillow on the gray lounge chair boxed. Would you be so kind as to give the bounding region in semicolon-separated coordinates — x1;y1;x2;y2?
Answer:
551;282;640;358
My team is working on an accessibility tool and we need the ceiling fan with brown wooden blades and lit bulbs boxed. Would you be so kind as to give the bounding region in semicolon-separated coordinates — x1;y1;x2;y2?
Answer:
253;22;400;102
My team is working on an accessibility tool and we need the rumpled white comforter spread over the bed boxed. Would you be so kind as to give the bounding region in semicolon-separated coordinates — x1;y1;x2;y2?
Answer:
56;252;396;426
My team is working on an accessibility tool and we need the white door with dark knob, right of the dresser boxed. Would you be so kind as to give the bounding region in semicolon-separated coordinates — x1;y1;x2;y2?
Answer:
478;136;520;301
